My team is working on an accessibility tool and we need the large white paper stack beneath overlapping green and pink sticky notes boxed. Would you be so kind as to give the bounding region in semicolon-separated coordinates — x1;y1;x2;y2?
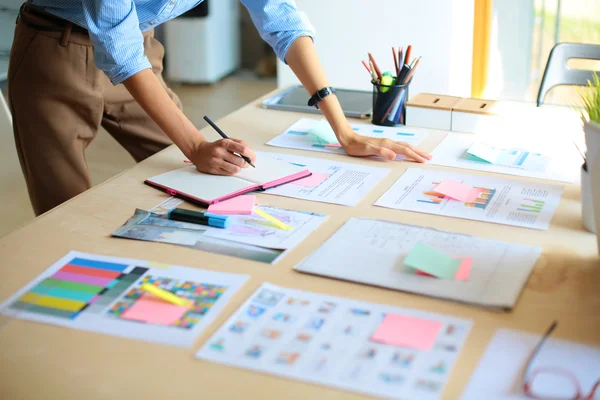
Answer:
294;218;541;309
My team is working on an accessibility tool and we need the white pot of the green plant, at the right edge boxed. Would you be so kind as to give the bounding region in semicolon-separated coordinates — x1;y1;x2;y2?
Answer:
583;122;600;254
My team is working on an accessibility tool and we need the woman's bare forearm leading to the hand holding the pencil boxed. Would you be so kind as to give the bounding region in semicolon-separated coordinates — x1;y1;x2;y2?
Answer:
123;69;206;158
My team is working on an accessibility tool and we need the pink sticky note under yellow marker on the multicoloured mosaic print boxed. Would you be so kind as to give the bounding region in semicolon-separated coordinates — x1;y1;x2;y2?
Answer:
121;296;189;325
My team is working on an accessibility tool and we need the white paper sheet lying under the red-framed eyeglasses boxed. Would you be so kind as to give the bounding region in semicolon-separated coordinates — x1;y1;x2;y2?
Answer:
461;324;600;400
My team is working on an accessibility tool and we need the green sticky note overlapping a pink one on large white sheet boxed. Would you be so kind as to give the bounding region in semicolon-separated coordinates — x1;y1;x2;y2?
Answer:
404;242;461;280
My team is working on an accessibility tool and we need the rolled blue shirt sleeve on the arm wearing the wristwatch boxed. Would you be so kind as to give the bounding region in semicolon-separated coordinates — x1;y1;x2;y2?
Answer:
241;0;316;62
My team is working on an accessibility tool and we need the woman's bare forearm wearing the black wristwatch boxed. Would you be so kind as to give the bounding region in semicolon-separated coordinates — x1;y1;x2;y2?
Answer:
286;37;348;139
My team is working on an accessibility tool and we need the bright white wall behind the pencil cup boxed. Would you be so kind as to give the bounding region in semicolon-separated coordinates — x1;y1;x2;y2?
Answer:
277;0;474;97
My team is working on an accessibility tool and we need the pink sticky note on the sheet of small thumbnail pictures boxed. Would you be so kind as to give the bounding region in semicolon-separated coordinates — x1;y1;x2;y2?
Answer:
371;314;443;350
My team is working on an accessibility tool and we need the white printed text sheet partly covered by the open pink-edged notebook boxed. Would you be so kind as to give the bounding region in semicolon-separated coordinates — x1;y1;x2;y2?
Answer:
257;152;390;206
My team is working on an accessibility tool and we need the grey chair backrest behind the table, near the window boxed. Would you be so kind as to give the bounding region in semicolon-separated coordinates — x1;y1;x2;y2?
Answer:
537;43;600;107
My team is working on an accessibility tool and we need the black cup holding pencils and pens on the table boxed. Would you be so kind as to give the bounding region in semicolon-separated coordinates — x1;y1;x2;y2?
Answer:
371;81;408;126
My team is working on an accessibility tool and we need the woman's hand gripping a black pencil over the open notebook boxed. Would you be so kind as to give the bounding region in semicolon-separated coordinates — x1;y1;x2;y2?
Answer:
190;139;256;175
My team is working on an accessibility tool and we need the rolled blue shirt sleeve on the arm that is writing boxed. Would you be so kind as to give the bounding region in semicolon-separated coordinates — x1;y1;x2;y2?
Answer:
83;0;152;85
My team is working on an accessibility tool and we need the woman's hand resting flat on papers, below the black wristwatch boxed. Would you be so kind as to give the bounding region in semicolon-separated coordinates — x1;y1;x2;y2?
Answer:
338;127;431;162
